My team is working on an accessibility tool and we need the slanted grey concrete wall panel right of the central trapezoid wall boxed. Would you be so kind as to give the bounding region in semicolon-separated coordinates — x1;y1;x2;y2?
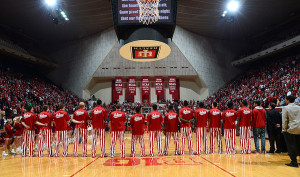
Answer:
173;26;239;95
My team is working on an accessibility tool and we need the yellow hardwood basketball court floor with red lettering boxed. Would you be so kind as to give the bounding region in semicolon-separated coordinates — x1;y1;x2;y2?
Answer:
0;132;300;177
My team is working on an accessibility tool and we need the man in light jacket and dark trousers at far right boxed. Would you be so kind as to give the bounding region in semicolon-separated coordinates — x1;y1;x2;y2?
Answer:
282;95;300;167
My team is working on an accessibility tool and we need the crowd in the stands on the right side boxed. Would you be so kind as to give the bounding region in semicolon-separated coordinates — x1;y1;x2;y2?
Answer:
205;55;300;110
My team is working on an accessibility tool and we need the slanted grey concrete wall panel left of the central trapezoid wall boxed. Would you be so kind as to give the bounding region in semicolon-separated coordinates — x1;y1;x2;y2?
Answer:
48;28;117;97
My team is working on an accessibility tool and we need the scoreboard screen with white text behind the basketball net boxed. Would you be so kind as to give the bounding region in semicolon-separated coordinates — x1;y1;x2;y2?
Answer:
118;0;173;24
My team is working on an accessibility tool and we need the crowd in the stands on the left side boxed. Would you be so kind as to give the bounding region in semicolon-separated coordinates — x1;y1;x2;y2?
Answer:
0;63;86;118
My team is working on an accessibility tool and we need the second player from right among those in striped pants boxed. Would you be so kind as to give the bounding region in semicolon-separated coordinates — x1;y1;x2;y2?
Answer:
222;109;237;154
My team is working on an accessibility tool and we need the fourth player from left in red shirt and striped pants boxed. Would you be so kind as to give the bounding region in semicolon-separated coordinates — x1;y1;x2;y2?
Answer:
73;109;89;157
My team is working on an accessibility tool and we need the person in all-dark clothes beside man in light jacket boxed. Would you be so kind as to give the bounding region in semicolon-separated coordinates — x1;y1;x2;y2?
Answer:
267;103;282;153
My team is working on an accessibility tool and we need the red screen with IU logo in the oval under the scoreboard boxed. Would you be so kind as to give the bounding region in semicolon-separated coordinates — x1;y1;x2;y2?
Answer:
131;46;160;59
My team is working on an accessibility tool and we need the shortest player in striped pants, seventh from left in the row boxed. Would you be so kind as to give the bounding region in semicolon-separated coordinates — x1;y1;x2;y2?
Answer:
130;113;146;157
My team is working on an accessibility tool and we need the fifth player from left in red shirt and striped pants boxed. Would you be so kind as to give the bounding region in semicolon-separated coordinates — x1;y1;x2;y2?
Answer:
91;106;107;157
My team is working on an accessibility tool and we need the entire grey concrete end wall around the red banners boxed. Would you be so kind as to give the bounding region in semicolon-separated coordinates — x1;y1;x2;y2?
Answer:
48;26;238;102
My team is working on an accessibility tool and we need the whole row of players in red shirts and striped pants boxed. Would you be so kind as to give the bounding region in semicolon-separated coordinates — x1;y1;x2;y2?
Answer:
3;100;266;158
